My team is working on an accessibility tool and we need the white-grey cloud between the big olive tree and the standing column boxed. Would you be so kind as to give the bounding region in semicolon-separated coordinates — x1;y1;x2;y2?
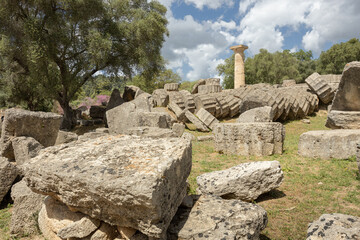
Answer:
162;15;236;81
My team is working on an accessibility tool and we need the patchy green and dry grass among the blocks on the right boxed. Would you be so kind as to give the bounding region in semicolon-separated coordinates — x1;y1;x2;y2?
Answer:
189;111;360;240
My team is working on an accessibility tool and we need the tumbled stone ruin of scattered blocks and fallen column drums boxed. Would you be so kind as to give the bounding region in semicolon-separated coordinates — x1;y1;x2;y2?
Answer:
0;60;360;240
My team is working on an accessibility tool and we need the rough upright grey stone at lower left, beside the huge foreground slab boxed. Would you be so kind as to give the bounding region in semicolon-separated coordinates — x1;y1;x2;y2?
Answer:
10;180;45;237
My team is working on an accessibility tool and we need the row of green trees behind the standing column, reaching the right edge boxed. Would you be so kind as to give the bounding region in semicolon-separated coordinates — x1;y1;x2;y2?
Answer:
217;38;360;88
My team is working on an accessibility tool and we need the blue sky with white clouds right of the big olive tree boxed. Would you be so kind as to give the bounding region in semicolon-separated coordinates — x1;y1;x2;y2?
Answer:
159;0;360;81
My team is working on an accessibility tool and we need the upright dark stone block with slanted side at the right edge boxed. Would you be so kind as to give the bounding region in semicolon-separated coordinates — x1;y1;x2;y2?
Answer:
331;62;360;111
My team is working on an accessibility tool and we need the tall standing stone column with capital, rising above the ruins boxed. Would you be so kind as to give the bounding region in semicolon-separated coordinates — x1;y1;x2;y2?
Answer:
230;45;248;89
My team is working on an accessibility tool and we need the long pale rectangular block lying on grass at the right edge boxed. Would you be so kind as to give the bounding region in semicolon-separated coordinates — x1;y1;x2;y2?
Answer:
298;129;360;159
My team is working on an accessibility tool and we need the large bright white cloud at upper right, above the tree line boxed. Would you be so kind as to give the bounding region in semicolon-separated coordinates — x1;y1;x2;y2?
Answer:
237;0;360;54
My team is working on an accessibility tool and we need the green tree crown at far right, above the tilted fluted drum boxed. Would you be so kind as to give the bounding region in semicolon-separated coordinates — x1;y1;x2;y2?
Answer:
316;38;360;74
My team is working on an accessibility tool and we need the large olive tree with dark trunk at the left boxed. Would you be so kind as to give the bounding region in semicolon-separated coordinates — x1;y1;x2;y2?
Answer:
0;0;168;127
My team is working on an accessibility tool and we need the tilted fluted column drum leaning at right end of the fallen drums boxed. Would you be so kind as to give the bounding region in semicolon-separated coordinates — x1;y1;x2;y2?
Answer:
305;72;334;104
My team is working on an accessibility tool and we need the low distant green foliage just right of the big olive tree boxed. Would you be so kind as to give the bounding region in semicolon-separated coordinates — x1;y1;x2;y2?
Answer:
127;69;181;93
